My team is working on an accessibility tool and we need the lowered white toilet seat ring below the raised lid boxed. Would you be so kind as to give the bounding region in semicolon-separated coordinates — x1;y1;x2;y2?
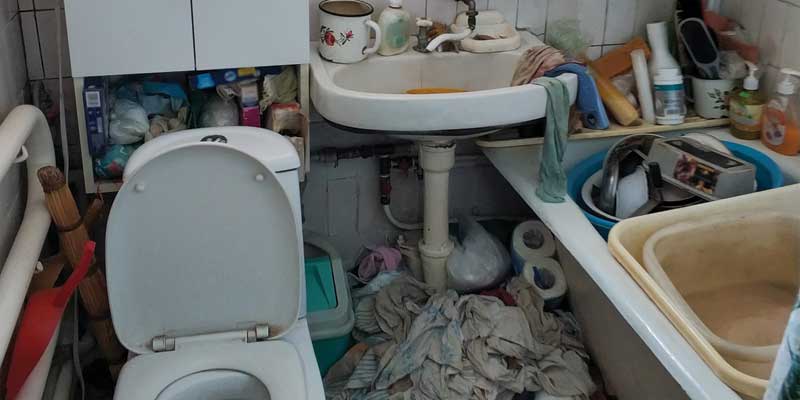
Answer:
114;340;307;400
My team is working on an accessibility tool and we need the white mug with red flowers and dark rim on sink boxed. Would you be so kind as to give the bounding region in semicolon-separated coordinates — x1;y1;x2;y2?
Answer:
319;0;381;64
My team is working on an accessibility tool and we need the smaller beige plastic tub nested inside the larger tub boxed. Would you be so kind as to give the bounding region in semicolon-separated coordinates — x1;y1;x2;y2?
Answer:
643;212;800;379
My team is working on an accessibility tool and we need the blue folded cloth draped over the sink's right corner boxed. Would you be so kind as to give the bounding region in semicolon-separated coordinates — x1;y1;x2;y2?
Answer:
544;63;609;129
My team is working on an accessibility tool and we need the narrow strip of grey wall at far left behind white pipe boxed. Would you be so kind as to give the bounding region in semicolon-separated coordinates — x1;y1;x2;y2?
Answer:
0;0;27;268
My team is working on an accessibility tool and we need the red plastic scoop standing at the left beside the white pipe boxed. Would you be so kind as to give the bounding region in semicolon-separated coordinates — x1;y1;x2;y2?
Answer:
6;241;96;400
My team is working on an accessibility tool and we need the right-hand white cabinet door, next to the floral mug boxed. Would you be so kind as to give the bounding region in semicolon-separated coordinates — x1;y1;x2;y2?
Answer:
192;0;309;70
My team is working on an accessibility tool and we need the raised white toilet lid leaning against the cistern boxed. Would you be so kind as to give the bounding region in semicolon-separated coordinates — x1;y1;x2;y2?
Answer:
106;138;302;354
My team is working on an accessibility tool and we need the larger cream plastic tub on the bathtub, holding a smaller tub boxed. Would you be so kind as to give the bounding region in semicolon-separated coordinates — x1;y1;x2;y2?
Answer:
608;185;800;398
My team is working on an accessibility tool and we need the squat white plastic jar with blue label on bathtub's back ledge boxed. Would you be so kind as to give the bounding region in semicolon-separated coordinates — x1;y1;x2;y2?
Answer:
653;68;686;125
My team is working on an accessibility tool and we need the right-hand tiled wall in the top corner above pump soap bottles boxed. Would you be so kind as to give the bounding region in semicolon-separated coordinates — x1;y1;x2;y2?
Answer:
722;0;800;90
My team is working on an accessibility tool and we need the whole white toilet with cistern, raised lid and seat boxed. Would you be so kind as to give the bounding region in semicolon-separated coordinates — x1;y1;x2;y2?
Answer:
106;127;325;400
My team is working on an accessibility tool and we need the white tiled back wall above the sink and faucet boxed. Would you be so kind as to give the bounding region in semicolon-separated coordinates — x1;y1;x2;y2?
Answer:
309;0;680;57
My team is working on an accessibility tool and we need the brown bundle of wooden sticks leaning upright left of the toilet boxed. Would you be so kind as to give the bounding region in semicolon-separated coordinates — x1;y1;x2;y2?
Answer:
37;166;128;379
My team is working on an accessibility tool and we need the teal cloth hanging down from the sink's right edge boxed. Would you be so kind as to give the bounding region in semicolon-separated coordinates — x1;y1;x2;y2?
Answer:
533;77;570;203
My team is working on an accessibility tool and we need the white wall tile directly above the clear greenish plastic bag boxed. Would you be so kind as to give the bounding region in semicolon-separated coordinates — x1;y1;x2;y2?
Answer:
547;0;608;45
